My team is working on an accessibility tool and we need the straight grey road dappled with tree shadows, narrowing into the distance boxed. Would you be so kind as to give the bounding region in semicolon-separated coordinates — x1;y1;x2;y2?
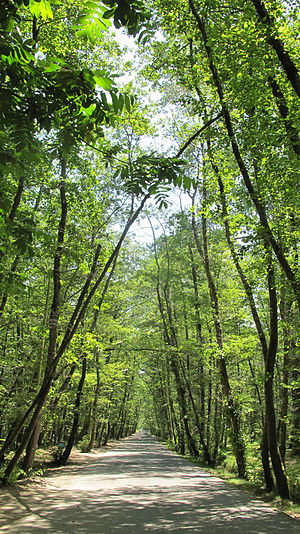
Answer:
0;433;300;534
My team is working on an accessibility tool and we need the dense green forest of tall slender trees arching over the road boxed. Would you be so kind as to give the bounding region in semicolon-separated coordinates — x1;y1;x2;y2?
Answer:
0;0;300;499
